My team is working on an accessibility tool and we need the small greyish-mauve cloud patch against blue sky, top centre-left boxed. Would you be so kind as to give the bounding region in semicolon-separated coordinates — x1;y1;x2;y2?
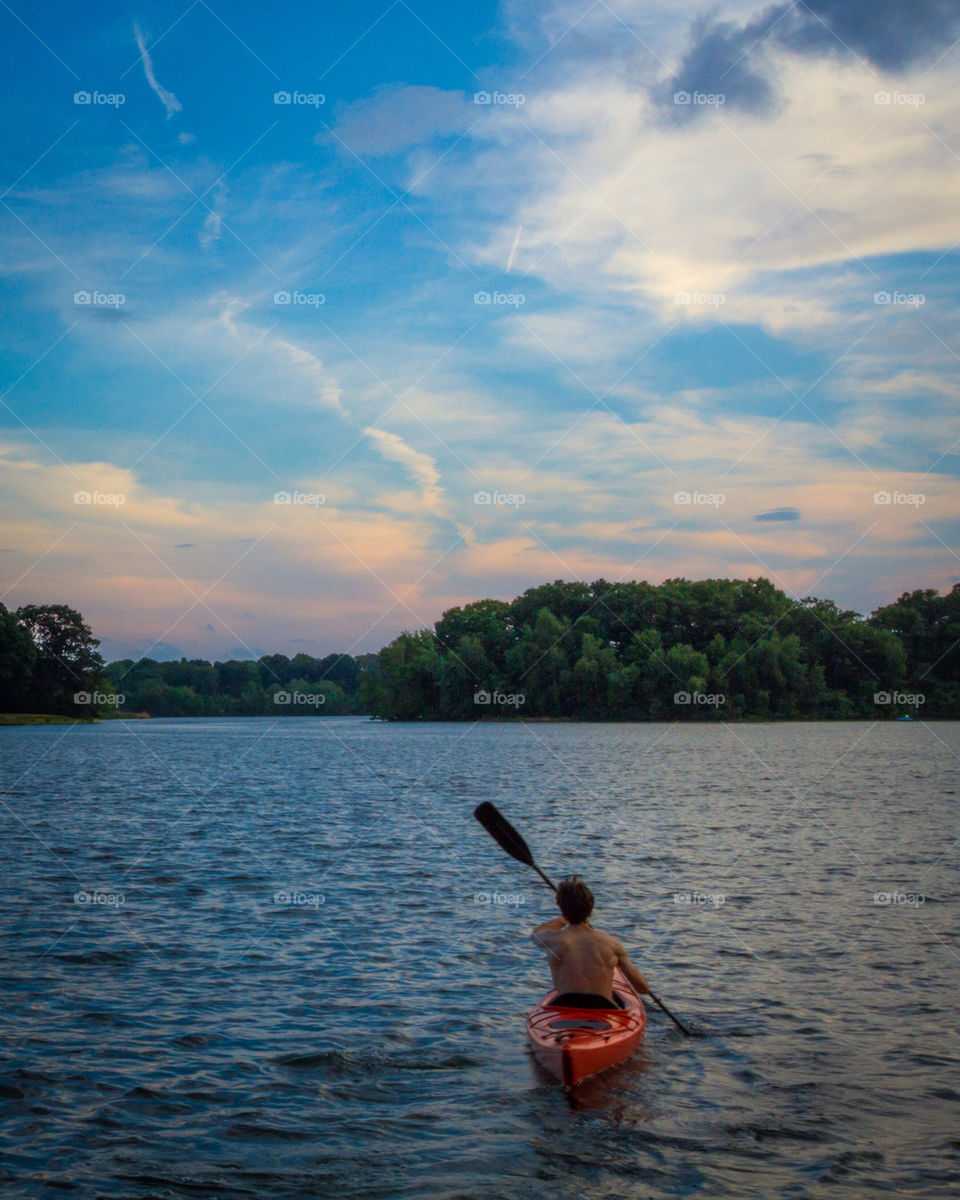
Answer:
328;85;476;155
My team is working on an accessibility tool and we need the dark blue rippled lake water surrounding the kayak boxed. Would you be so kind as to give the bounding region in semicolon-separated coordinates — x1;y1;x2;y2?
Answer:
0;718;960;1200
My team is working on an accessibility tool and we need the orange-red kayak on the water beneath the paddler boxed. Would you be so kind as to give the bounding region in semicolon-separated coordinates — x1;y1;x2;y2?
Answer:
527;967;647;1087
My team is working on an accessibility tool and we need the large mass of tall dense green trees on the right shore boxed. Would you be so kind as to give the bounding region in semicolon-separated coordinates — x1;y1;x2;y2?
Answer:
362;578;960;720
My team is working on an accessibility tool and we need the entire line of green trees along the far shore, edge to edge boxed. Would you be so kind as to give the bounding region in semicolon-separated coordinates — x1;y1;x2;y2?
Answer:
0;578;960;721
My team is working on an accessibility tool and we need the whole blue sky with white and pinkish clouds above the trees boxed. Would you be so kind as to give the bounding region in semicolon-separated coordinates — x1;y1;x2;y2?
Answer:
0;0;960;660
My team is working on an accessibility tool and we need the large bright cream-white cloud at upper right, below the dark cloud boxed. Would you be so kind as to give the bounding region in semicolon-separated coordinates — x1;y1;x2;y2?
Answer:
439;48;960;340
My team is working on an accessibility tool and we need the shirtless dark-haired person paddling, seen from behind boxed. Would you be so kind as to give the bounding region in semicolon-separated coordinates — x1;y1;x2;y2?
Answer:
530;875;650;1008
